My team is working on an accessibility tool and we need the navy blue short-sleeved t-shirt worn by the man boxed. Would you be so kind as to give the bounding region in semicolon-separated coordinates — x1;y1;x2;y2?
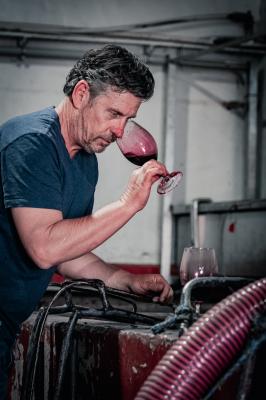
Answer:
0;107;98;332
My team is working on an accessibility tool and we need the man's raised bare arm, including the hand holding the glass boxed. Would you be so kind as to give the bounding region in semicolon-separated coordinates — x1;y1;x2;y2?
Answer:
12;160;167;269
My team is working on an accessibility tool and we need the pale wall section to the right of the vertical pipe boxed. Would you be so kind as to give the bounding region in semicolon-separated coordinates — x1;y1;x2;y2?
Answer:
176;70;246;203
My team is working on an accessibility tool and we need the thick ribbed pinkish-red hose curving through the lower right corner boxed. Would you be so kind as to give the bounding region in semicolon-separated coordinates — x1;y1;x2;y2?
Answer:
135;278;266;400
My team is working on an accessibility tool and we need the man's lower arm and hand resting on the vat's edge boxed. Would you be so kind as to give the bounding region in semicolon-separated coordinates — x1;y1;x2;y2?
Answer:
57;253;173;303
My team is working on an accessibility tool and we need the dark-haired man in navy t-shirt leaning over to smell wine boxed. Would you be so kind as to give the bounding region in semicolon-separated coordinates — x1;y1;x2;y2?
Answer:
0;45;172;399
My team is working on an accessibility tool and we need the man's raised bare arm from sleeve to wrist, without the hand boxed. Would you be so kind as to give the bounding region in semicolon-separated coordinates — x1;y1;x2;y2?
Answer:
12;200;136;269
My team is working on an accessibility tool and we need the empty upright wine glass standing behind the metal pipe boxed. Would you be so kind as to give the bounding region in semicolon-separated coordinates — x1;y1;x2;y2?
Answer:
179;247;218;286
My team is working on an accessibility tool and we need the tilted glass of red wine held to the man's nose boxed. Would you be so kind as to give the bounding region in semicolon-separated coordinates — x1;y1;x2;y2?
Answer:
116;120;183;194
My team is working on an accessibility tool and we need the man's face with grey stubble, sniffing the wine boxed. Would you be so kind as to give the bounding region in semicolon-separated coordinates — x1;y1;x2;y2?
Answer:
78;89;141;153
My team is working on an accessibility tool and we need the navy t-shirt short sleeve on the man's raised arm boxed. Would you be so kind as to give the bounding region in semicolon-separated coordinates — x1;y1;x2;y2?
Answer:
1;134;62;210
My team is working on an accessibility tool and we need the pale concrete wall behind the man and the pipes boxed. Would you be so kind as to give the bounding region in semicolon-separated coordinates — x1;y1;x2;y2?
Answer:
0;0;260;264
